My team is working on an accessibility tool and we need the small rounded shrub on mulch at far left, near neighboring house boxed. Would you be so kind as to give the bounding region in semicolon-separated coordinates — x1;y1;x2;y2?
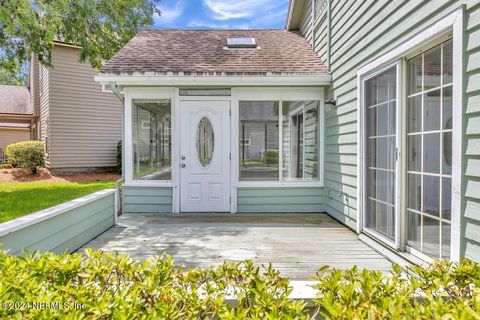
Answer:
5;141;45;173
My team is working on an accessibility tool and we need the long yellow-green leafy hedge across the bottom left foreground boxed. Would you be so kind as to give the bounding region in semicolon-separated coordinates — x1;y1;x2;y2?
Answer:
0;251;307;319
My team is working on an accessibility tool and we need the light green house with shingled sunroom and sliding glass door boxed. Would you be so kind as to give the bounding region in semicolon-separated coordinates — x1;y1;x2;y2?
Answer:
95;0;480;261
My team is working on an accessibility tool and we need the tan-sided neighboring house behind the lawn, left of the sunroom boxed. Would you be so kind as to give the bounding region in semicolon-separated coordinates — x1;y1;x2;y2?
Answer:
30;42;122;173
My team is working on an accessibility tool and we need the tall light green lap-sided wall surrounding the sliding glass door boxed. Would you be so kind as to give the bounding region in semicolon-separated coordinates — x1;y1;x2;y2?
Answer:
299;0;480;260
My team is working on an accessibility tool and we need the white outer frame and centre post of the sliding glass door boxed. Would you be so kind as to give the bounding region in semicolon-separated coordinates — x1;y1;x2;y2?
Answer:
357;8;464;261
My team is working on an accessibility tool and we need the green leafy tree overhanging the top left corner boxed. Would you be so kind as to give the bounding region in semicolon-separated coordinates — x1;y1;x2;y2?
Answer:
0;0;160;77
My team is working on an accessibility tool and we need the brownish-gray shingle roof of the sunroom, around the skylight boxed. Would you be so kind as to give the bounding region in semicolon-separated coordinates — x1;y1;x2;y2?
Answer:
101;30;329;75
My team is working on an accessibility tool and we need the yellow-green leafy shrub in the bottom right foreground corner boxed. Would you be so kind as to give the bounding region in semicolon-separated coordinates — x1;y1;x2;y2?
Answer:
315;260;480;319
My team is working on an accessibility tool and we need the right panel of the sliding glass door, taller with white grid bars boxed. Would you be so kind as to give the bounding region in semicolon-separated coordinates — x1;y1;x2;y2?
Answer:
406;41;453;259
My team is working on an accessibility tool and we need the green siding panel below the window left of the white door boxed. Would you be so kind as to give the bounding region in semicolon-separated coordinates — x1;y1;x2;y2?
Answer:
123;186;173;214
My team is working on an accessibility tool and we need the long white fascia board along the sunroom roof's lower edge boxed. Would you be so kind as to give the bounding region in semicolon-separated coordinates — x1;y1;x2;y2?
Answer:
95;75;332;87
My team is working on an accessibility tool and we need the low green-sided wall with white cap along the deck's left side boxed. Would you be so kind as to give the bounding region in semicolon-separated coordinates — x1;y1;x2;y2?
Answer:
0;189;115;255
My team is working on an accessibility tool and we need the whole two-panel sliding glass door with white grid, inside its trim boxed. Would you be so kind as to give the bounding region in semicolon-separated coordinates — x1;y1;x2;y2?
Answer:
360;40;455;260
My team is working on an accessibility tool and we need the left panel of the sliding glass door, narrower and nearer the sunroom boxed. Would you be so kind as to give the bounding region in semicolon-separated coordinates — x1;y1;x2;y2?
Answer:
363;65;398;243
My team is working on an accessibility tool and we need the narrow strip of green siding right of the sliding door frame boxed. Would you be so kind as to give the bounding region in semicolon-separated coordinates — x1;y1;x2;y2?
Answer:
461;3;480;261
